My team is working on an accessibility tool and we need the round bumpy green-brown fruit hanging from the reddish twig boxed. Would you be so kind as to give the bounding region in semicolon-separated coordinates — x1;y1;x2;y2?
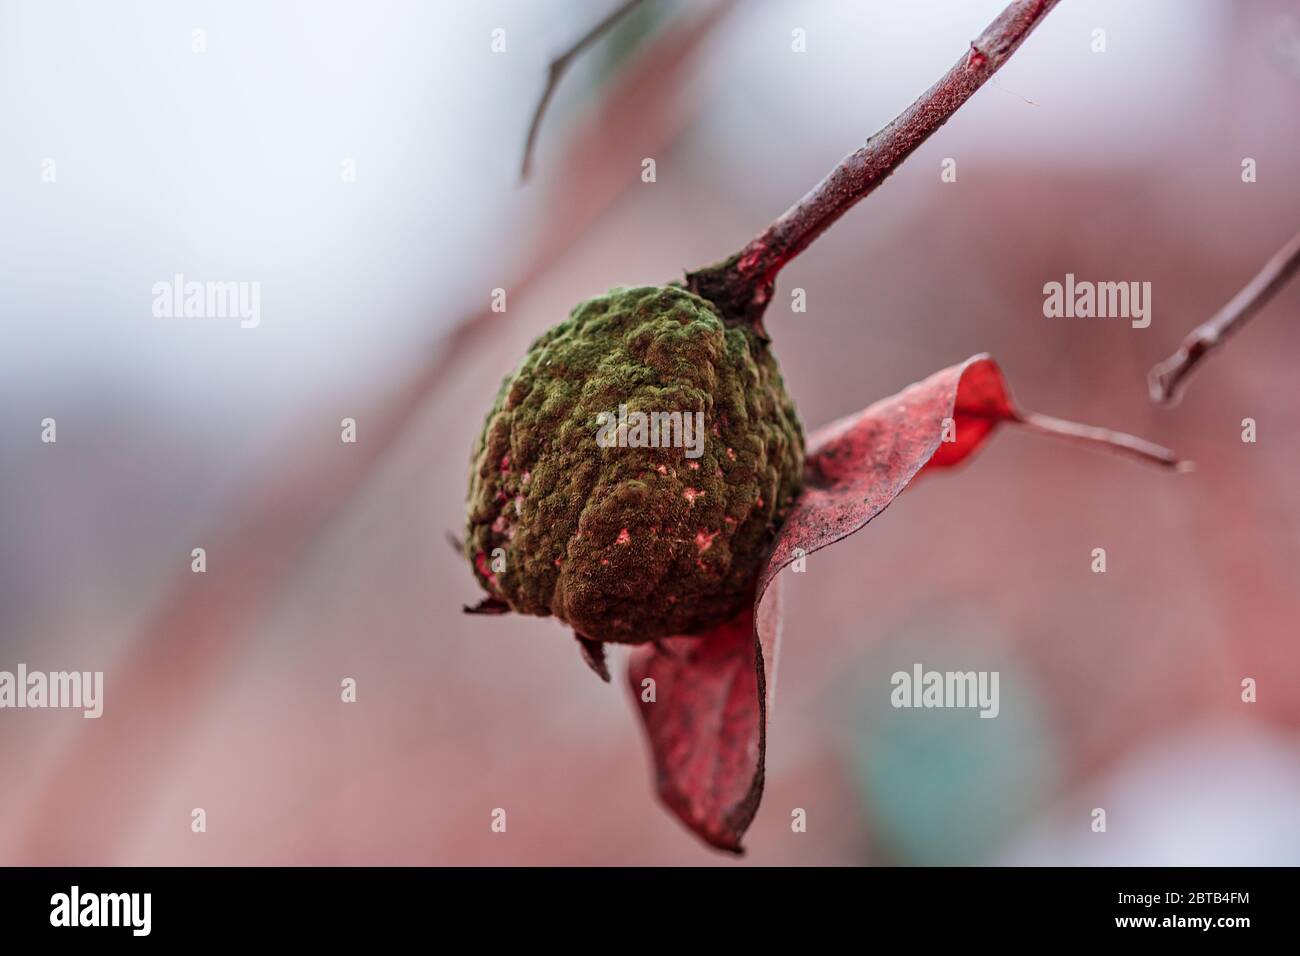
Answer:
465;286;803;643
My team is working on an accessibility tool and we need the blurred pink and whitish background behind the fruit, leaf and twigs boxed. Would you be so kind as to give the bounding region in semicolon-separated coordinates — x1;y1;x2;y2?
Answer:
0;0;1300;865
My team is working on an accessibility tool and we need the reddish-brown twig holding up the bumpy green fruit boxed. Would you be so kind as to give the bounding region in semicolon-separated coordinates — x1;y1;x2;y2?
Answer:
686;0;1058;338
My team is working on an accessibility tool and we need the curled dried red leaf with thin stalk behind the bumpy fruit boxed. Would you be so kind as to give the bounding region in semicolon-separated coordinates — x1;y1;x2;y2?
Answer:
629;355;1179;852
